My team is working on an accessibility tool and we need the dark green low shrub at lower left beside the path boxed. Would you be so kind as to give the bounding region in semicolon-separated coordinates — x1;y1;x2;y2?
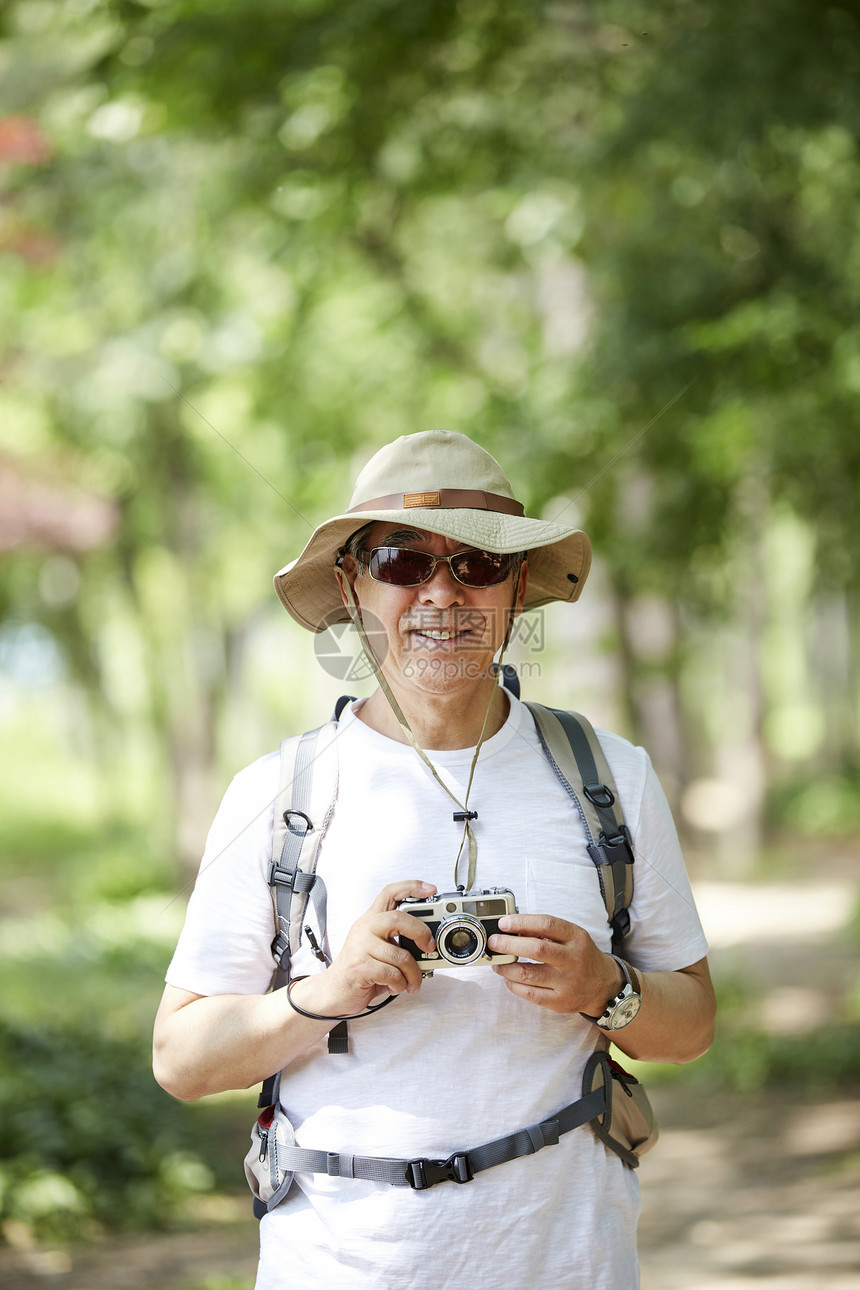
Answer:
0;1022;215;1240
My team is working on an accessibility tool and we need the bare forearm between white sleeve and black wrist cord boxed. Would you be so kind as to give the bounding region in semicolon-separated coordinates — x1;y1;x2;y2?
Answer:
152;982;334;1102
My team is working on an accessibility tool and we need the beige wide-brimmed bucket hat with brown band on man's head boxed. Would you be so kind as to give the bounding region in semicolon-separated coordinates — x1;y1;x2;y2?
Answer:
275;430;592;632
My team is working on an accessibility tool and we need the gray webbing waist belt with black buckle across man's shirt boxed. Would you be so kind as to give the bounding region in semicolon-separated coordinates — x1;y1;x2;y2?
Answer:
266;1086;606;1191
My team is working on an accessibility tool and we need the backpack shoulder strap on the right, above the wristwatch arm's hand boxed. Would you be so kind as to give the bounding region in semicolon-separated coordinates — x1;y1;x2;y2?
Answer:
526;703;633;953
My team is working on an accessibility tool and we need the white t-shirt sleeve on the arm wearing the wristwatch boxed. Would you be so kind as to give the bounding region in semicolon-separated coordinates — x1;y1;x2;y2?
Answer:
605;740;708;971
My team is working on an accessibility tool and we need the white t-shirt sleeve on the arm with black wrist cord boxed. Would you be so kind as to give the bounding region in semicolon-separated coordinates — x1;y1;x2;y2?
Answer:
165;753;279;995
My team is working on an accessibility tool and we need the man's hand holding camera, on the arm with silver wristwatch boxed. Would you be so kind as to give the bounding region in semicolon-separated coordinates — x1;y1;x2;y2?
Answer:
489;913;624;1017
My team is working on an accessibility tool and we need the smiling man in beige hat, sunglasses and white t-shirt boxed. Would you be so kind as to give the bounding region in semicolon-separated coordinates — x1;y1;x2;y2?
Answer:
155;431;714;1290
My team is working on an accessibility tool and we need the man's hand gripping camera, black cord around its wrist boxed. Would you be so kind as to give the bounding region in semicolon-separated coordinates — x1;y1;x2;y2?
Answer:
291;878;436;1017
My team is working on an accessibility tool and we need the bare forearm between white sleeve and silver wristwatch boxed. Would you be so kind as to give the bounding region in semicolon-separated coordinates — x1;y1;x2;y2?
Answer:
611;958;716;1063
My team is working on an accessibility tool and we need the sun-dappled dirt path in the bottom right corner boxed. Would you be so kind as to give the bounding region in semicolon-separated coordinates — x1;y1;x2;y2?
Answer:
640;1089;860;1290
